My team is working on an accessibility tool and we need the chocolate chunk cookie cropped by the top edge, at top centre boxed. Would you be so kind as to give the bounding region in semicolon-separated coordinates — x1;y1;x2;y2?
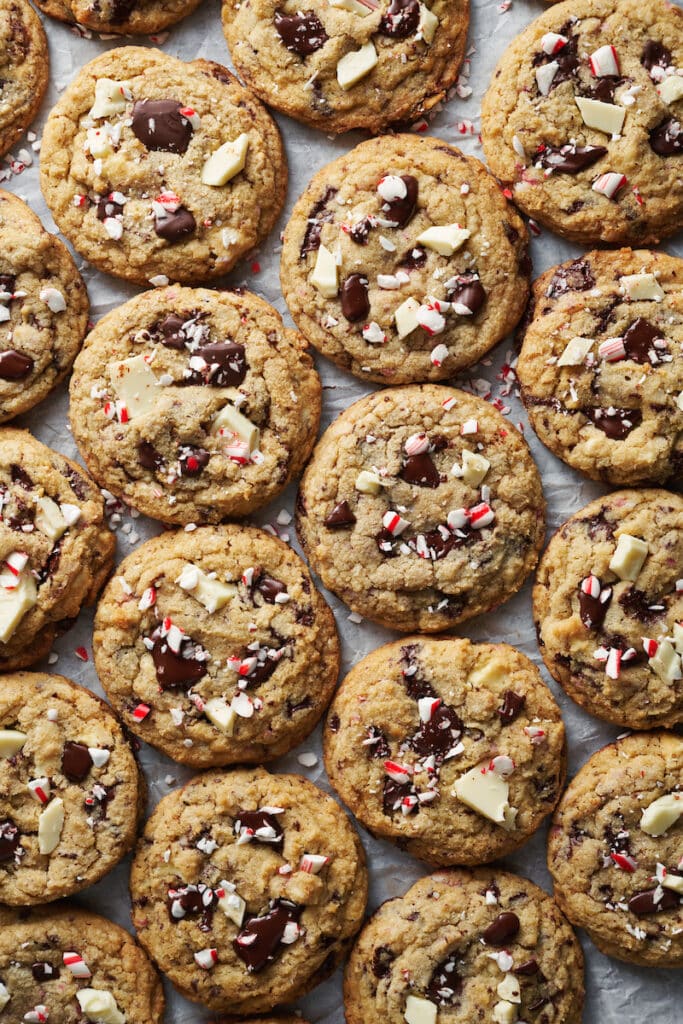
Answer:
223;0;469;133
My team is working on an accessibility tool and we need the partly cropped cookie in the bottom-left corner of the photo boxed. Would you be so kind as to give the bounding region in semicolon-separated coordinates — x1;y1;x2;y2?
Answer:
0;904;164;1024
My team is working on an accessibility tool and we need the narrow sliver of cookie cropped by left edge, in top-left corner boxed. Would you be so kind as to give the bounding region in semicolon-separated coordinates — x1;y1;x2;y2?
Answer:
0;0;49;157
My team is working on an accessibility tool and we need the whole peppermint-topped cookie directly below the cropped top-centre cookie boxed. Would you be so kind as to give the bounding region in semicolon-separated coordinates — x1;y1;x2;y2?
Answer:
281;135;530;384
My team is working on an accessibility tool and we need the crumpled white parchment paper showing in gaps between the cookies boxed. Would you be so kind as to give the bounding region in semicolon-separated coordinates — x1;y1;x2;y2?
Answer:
0;0;683;1024
